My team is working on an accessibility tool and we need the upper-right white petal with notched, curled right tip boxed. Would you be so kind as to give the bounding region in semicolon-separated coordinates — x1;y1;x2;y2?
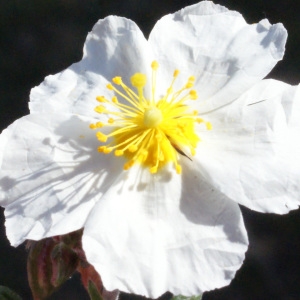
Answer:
149;1;287;112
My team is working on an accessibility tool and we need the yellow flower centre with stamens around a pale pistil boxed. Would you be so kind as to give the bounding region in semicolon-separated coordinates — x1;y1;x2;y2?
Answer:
90;61;212;174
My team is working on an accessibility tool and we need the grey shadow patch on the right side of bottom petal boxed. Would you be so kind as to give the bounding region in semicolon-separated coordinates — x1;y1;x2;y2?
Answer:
180;161;245;242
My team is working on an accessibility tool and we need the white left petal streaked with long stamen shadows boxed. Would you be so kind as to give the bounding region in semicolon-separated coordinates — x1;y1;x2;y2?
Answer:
0;114;122;246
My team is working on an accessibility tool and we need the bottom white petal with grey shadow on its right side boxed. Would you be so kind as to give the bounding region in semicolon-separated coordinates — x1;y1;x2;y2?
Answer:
83;163;248;298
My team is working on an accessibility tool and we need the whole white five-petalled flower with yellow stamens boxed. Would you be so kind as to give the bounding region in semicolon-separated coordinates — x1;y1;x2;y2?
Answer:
0;1;300;297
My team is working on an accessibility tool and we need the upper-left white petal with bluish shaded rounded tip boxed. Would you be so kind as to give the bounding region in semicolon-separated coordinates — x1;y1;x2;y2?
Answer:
29;16;152;117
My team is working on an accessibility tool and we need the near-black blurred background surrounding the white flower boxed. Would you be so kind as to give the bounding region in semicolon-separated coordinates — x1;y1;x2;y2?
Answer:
0;0;300;300
